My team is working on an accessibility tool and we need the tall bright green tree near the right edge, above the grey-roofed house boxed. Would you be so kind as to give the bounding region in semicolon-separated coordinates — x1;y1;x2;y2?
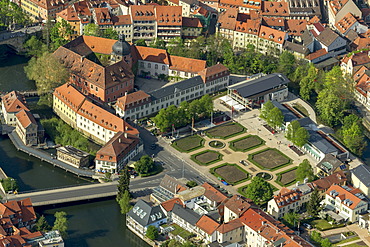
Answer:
340;114;366;156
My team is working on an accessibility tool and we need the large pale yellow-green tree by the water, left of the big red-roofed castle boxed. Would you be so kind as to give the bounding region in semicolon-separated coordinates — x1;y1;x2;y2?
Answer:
24;52;69;94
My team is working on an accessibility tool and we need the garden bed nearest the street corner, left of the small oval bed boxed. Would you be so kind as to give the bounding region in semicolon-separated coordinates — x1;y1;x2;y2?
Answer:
210;163;249;185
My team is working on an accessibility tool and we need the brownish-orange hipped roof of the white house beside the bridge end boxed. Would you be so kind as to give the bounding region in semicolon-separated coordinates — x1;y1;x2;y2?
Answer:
95;131;140;162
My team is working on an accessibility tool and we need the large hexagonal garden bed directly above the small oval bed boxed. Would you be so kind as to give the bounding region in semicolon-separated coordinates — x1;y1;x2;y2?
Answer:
248;148;292;171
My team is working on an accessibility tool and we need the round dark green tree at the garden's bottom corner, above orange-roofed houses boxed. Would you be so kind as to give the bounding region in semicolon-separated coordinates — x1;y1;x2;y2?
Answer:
245;176;272;205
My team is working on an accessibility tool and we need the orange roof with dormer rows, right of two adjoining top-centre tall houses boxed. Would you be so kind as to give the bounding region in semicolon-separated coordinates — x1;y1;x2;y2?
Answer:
154;6;182;26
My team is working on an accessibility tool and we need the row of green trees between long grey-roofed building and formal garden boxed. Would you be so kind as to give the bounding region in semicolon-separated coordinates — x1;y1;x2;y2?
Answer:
153;95;213;132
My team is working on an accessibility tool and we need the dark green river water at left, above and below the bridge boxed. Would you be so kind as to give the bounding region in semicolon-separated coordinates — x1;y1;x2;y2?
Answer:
0;45;148;247
